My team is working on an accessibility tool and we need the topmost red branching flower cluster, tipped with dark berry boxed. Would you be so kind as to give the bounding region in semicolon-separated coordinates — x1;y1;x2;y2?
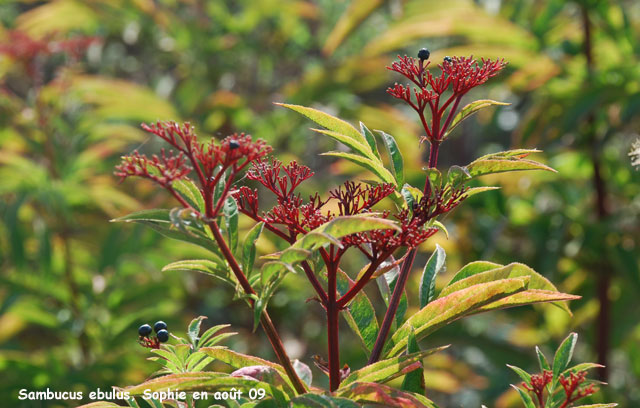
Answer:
387;55;506;142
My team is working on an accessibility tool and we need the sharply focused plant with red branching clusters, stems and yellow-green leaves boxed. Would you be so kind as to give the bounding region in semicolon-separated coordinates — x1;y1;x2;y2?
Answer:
105;49;596;406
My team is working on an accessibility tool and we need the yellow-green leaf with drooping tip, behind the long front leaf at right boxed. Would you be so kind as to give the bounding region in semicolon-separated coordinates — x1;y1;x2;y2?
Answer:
439;262;576;314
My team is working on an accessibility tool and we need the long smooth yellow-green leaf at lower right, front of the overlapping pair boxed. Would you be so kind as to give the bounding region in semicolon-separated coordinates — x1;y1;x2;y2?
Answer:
384;277;529;356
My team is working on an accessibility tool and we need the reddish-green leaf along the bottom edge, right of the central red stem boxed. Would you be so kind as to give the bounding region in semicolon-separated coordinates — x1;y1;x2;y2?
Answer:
335;382;437;408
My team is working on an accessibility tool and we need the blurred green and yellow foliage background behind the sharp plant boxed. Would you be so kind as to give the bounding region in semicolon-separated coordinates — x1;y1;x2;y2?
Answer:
0;0;640;408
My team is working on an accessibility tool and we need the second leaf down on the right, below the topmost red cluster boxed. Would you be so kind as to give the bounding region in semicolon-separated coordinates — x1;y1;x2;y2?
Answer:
467;149;556;178
